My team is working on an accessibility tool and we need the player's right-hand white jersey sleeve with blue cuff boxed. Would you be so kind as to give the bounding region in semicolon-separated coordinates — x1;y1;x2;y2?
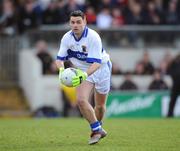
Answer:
86;32;102;63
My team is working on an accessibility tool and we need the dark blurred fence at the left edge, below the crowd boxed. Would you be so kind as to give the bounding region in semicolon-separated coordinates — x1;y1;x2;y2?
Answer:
0;36;22;87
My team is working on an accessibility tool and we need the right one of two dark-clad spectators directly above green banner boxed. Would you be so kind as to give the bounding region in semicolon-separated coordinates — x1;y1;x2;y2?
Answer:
148;69;168;90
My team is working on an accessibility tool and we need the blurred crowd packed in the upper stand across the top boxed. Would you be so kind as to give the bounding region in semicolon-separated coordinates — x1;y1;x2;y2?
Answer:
0;0;180;34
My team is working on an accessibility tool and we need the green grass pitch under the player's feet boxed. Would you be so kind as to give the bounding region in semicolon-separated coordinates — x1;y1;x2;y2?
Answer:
0;118;180;151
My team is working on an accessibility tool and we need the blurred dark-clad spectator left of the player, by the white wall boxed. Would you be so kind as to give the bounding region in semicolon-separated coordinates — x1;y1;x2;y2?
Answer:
36;40;57;74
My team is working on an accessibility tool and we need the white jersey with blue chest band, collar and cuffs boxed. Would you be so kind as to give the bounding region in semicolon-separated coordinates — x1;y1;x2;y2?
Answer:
57;27;109;71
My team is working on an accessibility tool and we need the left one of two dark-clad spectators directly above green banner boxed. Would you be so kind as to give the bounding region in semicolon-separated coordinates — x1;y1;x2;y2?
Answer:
119;72;138;90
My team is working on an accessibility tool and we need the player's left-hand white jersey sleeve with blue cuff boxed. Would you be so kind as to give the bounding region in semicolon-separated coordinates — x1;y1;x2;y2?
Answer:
57;35;68;60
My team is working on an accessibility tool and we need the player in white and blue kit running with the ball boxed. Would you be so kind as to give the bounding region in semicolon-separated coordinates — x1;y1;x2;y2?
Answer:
56;10;112;145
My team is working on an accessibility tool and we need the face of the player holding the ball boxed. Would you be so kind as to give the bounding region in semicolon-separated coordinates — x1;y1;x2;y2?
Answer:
70;16;86;37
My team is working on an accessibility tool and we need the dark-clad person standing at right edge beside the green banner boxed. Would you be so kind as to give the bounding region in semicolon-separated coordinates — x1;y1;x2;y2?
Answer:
167;53;180;117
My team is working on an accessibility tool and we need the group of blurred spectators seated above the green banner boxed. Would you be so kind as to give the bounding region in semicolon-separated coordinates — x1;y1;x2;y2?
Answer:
112;51;174;90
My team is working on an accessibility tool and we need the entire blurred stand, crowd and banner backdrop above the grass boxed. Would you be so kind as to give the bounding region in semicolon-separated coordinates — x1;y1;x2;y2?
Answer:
0;0;180;117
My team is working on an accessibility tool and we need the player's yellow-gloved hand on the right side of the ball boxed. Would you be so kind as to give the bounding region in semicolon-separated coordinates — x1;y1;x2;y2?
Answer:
72;69;88;87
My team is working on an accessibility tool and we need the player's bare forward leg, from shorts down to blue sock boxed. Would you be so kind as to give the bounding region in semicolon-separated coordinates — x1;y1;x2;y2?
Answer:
76;81;97;124
